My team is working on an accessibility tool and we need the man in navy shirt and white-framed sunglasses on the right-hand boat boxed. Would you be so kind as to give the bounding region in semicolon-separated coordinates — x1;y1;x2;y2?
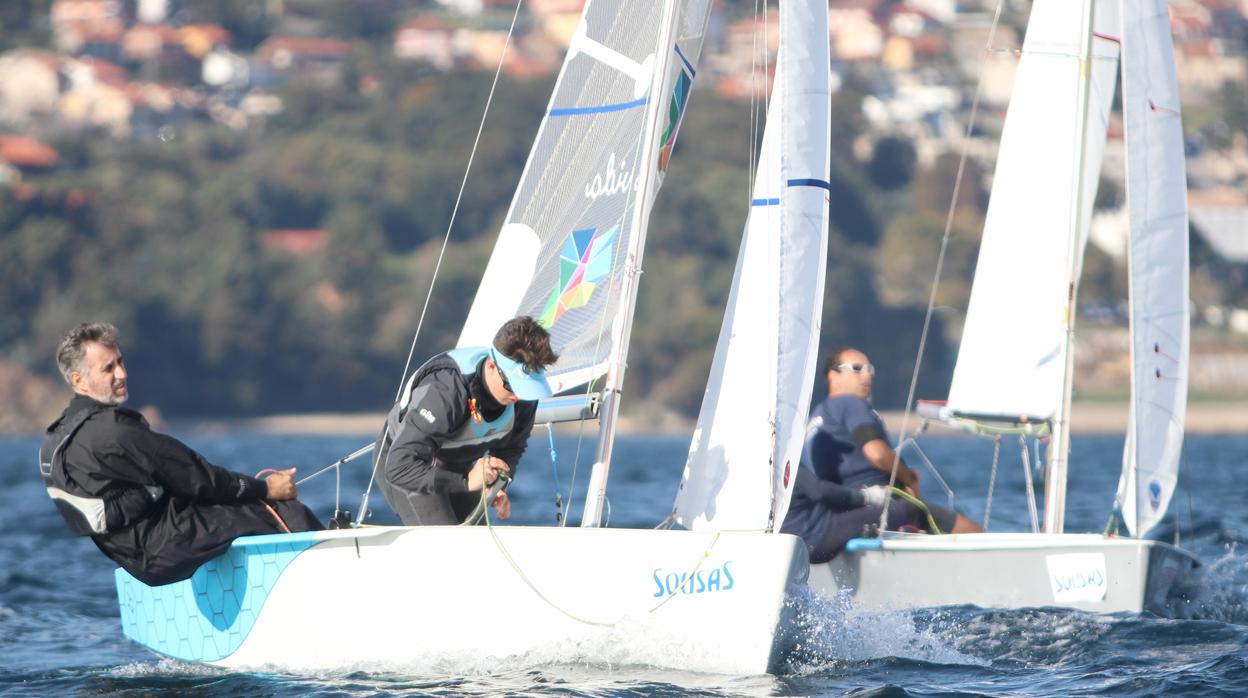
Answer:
801;347;982;533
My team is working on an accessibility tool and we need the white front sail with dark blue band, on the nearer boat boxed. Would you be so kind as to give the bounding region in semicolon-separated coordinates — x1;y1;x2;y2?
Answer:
674;1;830;531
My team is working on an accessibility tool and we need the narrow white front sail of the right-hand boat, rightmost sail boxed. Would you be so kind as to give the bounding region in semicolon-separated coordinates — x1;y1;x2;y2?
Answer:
1118;0;1189;537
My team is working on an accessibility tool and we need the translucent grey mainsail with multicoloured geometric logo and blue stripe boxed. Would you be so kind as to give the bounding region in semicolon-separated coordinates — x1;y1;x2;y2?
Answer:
458;0;710;392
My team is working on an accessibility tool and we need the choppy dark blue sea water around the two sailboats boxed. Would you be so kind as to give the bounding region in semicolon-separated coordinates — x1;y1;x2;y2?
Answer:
0;427;1248;697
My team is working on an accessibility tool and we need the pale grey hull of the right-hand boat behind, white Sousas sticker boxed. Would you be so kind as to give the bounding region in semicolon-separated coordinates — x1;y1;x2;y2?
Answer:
810;533;1196;616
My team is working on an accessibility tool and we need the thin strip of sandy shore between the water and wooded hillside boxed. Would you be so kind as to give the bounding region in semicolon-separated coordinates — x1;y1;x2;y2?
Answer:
183;402;1248;437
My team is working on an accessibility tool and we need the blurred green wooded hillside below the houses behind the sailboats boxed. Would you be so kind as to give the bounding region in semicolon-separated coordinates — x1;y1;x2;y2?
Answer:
0;0;1248;428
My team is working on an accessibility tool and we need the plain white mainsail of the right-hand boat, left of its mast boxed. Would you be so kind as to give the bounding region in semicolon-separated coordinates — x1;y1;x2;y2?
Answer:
948;0;1118;421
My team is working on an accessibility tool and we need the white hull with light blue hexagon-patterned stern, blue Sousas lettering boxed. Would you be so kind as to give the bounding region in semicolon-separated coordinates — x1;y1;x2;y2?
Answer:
117;526;809;674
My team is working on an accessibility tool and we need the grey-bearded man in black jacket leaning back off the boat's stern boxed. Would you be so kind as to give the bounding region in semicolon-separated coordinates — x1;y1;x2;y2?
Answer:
39;322;322;586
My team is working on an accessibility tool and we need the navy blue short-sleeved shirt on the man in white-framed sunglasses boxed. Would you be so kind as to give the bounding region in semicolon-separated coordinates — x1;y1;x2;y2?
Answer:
801;395;889;487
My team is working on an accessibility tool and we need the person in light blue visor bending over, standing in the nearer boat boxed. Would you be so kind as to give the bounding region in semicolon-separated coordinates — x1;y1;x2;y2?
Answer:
373;316;559;526
